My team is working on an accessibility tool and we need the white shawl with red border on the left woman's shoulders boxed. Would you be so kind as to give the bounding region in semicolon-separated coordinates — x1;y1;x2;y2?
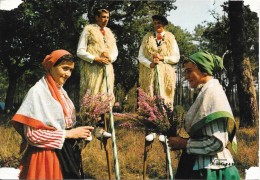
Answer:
12;77;68;132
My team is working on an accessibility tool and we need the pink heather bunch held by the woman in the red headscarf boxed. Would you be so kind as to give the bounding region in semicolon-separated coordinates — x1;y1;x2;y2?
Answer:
80;90;113;125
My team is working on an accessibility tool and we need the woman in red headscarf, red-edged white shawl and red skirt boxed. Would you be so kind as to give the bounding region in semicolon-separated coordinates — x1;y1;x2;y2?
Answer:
12;49;93;179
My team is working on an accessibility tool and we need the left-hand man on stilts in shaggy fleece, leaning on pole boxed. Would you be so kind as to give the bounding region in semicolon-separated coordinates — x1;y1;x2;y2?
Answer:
77;8;118;137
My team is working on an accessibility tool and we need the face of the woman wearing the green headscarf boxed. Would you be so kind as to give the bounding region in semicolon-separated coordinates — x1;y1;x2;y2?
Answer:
184;62;206;88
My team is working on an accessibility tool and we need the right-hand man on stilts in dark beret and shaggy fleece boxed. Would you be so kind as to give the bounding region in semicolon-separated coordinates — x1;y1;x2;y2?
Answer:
138;15;180;179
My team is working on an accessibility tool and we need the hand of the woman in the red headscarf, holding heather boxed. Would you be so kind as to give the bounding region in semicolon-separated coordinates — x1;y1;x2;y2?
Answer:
66;126;94;140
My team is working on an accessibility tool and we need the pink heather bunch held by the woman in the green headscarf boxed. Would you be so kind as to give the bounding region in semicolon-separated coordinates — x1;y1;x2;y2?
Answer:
137;88;178;135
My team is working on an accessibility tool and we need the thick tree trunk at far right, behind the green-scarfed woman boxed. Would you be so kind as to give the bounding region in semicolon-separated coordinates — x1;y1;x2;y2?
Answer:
229;1;258;127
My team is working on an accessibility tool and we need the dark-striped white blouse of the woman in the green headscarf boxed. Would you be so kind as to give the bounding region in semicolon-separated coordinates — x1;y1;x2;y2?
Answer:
187;118;234;170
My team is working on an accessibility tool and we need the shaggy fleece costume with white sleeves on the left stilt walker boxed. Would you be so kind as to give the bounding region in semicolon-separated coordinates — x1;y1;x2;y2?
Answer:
77;24;118;104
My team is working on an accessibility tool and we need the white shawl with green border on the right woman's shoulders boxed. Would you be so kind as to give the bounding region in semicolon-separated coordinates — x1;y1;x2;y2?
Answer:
185;79;237;153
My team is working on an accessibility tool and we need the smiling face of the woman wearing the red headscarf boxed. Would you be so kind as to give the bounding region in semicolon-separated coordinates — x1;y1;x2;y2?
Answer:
50;61;75;85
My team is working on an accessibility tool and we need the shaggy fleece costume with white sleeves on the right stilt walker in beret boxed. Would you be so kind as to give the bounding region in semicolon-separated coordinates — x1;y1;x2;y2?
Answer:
138;31;180;108
